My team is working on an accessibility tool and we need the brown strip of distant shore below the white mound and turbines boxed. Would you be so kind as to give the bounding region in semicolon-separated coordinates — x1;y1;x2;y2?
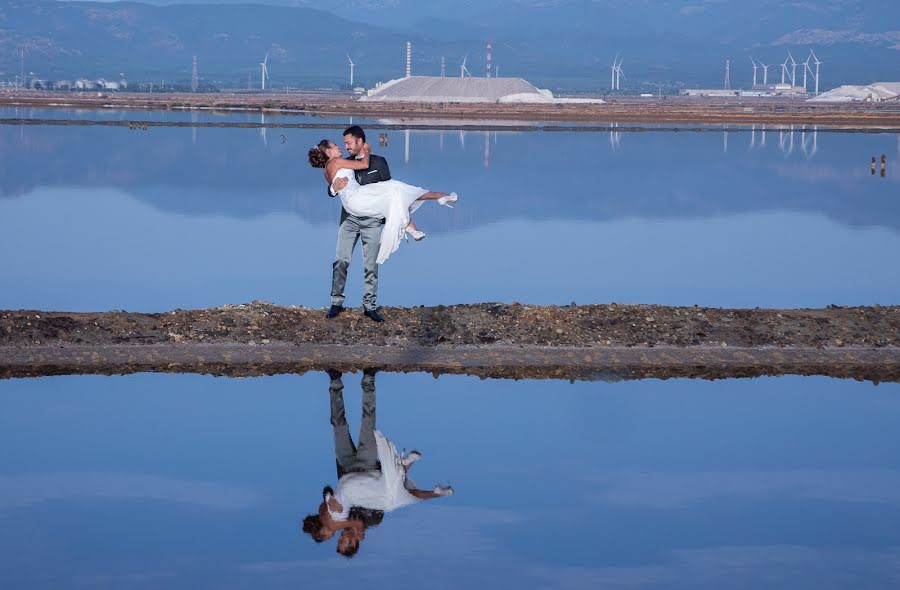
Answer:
0;91;900;130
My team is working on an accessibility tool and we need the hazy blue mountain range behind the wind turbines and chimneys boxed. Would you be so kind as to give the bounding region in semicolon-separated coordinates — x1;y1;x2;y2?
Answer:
0;0;900;92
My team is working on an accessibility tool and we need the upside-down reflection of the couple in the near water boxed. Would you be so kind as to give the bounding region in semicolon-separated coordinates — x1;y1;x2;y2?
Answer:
303;370;453;557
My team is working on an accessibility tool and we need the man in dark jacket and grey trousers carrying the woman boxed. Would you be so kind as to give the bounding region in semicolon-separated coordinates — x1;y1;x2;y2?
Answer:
325;125;391;322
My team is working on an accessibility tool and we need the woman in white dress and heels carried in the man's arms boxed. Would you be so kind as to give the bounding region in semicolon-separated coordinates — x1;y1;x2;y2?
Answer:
309;139;457;264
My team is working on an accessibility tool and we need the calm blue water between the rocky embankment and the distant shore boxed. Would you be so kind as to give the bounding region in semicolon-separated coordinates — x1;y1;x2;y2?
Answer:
0;109;900;311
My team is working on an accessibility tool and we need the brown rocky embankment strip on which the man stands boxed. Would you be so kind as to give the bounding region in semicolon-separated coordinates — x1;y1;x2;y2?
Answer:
0;302;900;381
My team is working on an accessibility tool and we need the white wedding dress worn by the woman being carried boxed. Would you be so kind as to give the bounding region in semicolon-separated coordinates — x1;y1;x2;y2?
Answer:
332;168;428;264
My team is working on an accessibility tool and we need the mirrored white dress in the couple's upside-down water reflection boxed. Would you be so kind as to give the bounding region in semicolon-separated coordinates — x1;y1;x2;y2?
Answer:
332;430;419;520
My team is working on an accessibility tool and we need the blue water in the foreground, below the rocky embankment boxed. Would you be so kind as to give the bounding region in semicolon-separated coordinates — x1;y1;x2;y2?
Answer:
0;373;900;589
